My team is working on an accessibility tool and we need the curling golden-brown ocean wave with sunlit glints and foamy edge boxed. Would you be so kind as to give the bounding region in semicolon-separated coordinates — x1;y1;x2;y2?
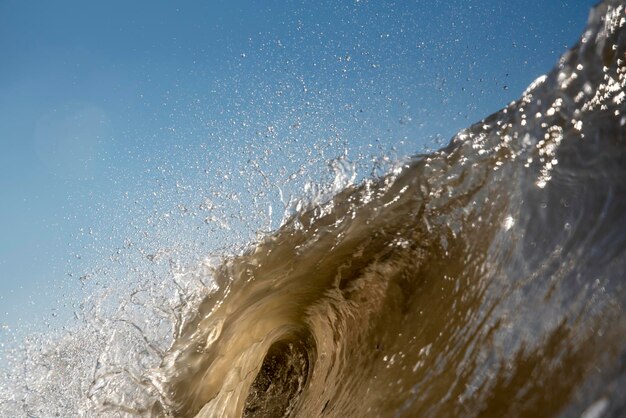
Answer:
0;0;626;418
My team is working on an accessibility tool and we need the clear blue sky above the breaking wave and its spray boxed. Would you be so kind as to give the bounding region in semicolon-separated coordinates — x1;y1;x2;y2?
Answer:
0;0;594;333
